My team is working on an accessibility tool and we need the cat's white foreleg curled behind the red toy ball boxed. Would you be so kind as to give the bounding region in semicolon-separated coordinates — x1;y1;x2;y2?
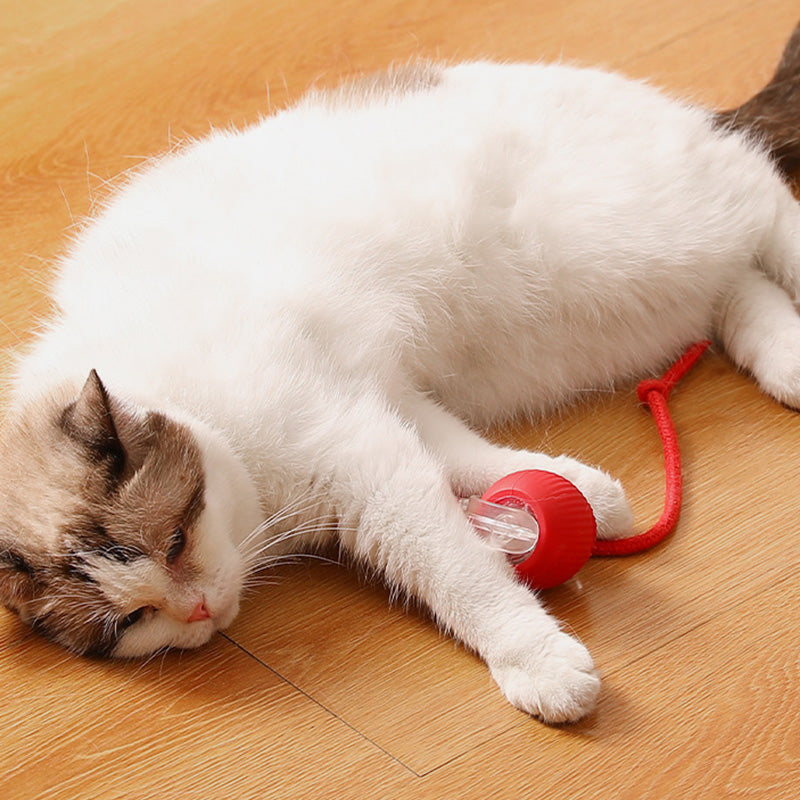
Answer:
403;394;633;539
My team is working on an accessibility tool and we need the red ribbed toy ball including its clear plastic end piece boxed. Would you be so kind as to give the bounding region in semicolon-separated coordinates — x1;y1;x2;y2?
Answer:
466;470;597;589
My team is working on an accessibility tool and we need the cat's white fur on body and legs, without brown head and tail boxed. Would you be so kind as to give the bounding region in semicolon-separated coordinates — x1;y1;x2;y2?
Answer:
10;63;800;721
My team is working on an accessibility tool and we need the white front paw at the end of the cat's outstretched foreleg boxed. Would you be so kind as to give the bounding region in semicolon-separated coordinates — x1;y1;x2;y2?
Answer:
489;631;600;724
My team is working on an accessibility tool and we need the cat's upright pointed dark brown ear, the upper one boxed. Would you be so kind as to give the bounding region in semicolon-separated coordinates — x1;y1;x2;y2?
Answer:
61;370;125;472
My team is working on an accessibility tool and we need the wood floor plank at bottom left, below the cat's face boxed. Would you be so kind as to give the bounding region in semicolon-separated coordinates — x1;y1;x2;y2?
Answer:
0;614;408;800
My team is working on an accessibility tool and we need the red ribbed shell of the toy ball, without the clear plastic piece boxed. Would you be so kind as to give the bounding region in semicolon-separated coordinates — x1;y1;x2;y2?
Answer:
481;470;597;589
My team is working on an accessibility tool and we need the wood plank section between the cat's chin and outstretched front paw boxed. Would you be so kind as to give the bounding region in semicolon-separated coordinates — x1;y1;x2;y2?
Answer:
228;565;520;774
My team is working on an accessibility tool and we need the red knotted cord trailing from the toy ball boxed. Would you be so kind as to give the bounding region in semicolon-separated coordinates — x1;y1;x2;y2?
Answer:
592;342;711;556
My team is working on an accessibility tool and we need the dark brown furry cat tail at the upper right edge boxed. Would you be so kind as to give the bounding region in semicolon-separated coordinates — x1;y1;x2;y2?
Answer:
716;23;800;175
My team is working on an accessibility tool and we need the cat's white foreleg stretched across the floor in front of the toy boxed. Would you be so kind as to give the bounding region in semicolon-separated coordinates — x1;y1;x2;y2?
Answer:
330;400;600;722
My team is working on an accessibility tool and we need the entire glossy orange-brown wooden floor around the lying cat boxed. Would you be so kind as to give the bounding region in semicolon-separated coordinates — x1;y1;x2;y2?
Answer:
0;0;800;800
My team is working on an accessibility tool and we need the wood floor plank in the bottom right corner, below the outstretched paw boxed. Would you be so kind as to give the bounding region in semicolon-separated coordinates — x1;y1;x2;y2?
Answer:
412;578;800;800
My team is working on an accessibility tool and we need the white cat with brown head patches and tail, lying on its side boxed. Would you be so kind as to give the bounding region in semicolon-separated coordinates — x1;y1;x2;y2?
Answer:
0;25;800;723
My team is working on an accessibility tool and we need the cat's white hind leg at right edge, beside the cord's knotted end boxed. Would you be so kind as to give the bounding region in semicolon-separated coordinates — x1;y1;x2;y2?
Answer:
717;262;800;408
